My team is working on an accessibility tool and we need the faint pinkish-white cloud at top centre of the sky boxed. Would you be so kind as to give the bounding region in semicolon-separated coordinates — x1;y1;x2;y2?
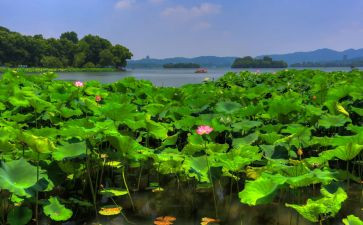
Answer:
161;3;221;20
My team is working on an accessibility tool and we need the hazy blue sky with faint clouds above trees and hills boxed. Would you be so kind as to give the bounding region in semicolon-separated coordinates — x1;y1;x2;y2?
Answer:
0;0;363;59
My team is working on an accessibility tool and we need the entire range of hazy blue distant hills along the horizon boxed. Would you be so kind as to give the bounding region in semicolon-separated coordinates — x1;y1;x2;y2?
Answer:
127;48;363;68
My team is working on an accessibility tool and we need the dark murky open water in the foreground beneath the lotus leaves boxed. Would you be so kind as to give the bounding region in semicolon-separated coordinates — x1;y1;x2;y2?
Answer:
84;182;363;225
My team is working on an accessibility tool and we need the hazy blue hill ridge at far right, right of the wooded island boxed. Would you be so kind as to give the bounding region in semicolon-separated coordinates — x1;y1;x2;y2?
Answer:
257;48;363;65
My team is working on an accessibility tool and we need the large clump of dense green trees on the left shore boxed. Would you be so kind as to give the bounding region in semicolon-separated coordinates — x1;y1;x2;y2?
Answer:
0;27;132;70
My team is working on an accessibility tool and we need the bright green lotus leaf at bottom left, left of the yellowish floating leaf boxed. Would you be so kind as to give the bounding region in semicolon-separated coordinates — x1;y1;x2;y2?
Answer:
43;197;73;221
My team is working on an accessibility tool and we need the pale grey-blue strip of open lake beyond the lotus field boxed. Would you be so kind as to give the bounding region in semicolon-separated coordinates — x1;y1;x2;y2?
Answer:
52;67;363;87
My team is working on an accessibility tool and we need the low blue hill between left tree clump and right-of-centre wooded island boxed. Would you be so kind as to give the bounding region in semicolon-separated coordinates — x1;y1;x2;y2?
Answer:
127;56;237;68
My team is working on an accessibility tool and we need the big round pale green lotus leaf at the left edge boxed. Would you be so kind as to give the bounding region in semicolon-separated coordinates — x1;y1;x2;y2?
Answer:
0;159;37;196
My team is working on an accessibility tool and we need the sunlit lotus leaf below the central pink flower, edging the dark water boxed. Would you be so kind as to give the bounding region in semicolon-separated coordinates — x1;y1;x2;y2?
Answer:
182;156;210;183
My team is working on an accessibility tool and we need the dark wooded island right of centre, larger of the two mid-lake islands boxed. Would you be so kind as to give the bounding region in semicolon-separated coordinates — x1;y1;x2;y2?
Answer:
232;56;288;68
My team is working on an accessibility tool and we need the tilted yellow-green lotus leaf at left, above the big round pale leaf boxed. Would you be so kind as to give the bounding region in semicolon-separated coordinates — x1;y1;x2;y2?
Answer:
23;132;55;153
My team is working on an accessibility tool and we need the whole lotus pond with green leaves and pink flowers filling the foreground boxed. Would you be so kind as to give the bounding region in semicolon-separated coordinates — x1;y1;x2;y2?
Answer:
0;70;363;225
